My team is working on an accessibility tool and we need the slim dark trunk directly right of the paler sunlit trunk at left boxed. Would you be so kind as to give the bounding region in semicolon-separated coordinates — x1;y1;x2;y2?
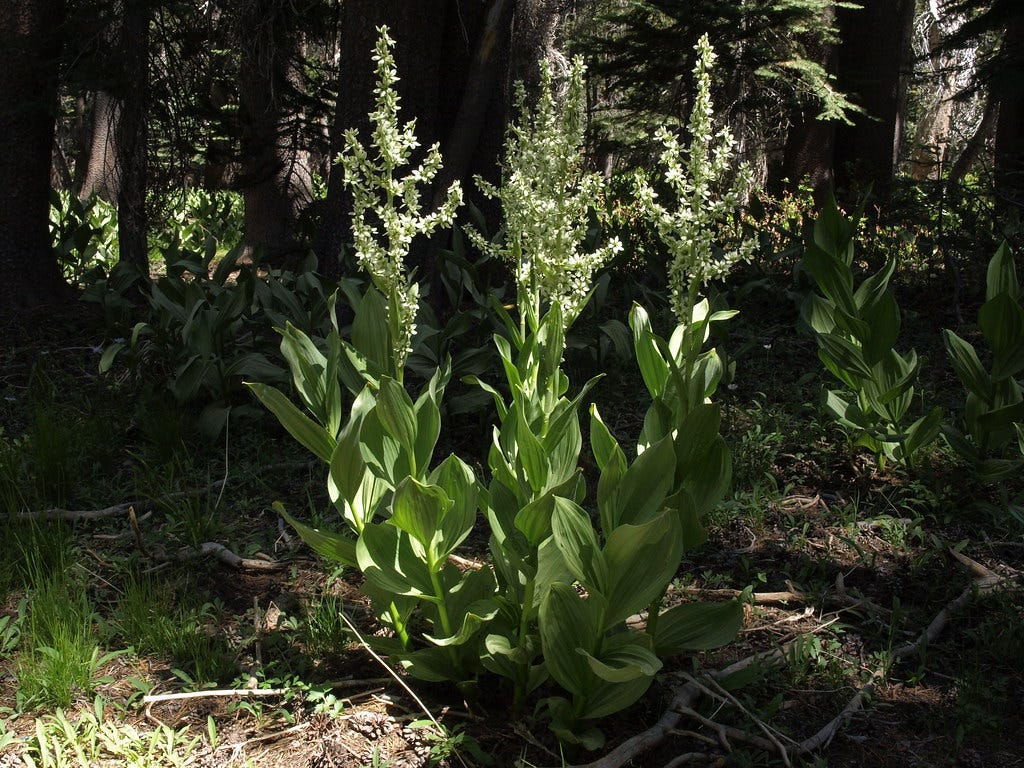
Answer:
115;0;150;274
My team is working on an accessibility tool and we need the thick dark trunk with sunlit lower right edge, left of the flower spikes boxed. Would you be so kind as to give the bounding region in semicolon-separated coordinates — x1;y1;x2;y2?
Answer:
239;0;312;263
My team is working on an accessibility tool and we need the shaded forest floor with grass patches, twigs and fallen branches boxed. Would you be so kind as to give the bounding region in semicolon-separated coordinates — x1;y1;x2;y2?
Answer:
0;284;1024;768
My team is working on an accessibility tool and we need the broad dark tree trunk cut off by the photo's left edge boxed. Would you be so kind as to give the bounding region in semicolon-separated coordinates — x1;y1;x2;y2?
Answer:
0;0;70;316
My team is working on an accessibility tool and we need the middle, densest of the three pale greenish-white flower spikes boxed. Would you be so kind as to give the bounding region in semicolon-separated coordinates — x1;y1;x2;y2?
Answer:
468;58;622;327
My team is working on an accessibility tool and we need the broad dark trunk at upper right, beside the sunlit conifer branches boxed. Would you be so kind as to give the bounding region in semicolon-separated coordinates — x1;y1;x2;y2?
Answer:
834;0;914;200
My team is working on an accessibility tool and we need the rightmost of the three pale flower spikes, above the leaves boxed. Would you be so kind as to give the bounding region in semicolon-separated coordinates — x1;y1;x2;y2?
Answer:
638;35;756;324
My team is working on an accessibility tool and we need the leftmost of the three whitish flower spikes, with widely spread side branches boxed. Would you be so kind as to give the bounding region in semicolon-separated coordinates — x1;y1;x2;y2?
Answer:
338;27;462;370
